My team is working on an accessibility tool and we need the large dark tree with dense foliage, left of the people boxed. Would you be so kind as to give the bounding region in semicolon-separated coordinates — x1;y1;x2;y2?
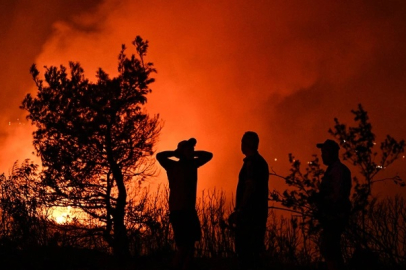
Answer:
21;36;161;257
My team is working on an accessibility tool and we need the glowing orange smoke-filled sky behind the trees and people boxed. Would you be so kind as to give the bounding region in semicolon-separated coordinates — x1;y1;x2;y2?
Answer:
0;0;406;200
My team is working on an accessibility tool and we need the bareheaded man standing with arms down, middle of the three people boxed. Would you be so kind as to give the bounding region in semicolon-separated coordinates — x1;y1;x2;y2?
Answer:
229;131;269;269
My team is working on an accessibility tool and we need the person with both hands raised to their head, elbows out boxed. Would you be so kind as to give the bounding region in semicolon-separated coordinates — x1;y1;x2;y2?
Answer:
156;138;213;269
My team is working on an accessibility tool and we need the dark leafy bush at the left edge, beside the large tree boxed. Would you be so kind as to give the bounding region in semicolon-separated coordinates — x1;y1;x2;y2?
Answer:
0;160;47;248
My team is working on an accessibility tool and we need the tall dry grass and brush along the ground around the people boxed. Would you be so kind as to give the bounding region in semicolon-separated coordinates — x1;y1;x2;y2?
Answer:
0;167;406;269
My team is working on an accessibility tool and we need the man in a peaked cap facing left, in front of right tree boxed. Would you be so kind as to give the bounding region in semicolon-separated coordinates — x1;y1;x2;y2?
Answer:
313;140;351;270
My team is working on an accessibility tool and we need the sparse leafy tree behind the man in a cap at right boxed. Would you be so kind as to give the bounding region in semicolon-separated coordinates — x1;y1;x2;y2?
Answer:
270;104;405;262
